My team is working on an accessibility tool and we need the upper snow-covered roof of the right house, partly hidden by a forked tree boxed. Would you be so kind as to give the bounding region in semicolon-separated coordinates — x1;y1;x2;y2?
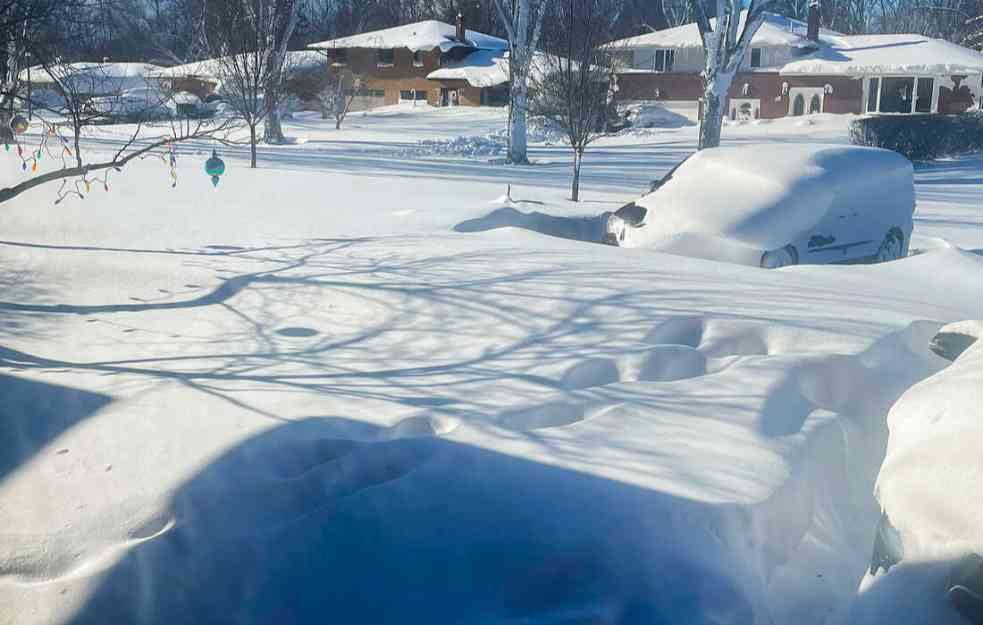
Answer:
605;11;840;50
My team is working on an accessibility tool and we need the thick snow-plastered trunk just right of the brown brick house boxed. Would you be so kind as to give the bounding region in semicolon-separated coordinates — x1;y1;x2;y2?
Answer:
494;0;549;164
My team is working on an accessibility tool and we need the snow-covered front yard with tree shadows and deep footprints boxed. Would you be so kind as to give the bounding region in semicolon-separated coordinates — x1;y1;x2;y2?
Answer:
0;107;983;625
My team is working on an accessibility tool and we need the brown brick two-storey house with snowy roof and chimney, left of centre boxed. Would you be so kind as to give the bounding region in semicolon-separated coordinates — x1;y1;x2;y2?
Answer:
308;16;509;110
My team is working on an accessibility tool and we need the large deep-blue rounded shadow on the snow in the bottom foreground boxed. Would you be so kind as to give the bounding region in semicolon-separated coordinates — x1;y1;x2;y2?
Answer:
63;418;753;625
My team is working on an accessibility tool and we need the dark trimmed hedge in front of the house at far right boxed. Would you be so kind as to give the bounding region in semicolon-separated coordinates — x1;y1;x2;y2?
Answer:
850;111;983;161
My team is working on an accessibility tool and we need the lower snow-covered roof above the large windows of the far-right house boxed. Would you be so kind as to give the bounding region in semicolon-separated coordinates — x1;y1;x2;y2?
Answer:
781;35;983;74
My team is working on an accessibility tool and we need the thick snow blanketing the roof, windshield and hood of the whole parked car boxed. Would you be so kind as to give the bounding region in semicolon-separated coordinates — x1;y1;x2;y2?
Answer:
629;144;914;254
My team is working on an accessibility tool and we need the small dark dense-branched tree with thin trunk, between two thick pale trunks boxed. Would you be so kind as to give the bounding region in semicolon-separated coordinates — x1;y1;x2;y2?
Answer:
529;0;614;202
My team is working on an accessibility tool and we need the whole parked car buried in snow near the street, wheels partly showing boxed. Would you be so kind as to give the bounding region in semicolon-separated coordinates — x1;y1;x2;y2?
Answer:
608;144;915;268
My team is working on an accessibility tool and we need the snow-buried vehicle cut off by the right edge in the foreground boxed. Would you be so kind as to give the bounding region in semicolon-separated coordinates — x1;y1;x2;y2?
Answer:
851;321;983;625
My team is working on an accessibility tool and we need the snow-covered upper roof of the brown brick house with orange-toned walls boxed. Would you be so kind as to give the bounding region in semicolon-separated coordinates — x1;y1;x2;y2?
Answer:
308;20;508;52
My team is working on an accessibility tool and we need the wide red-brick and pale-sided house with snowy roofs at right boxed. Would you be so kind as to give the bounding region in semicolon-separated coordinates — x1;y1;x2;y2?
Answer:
606;8;983;121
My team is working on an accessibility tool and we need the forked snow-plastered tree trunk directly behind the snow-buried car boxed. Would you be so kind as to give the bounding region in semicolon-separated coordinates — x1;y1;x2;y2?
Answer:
691;0;776;150
